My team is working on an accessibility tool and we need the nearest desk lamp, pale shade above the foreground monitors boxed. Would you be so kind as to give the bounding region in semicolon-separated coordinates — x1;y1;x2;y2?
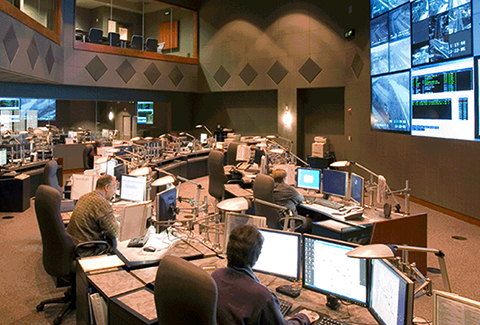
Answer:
346;244;452;298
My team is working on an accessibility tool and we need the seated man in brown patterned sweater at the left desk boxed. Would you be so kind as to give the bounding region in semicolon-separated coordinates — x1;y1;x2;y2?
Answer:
67;175;119;256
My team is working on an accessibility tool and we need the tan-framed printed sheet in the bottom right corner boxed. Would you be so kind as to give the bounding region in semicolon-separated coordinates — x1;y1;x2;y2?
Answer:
432;290;480;325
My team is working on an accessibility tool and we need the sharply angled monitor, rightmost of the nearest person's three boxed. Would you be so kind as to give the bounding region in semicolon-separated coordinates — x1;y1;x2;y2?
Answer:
368;259;414;325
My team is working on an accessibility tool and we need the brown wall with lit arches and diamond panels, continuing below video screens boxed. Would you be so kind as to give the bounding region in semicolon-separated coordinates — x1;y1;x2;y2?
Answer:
198;0;480;219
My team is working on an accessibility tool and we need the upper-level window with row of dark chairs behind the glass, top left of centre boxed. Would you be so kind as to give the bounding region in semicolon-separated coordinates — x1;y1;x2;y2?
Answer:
75;0;197;59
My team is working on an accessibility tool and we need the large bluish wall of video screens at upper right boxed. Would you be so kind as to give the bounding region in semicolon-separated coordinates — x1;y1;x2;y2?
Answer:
370;0;480;140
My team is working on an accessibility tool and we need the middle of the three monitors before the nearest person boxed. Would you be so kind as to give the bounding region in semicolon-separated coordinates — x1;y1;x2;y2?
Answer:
302;234;368;307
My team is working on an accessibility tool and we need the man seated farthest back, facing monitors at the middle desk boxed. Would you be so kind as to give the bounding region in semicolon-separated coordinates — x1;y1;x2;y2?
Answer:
271;169;304;213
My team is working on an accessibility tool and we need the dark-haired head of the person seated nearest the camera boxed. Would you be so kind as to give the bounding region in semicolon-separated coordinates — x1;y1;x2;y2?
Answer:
227;225;263;268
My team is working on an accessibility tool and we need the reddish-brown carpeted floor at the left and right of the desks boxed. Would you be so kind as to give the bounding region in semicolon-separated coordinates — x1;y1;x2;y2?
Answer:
0;177;480;325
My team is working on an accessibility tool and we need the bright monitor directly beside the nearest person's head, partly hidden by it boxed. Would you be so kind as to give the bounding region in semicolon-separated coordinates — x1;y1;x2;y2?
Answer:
253;228;301;280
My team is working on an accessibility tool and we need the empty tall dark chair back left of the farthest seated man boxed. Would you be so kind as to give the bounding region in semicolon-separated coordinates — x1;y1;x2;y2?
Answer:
207;150;227;202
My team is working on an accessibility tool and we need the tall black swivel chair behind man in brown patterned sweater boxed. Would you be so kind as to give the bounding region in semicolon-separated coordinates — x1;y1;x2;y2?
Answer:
35;185;109;325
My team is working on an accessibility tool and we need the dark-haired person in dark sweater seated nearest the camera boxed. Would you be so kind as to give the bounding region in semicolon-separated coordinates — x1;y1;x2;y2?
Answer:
212;225;318;325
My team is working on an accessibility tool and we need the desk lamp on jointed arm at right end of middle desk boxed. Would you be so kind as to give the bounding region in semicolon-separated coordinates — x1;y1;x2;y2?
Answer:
330;160;410;215
